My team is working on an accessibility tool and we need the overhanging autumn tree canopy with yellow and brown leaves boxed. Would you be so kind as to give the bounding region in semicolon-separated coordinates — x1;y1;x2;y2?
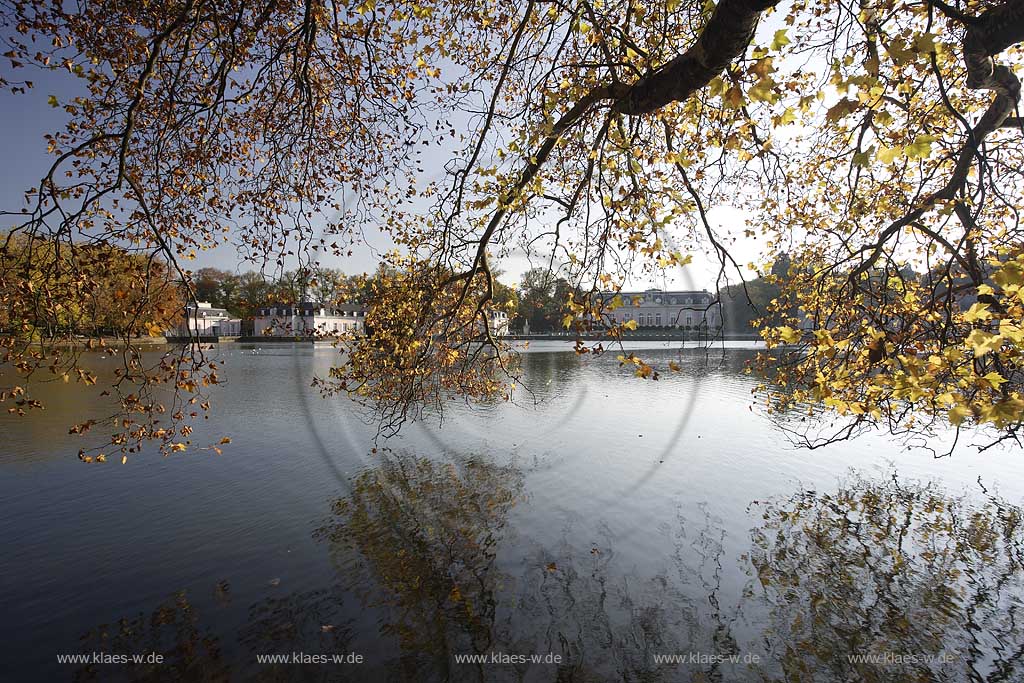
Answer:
0;0;1024;456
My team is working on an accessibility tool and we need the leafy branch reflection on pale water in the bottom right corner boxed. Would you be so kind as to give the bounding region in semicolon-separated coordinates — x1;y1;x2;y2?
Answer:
751;478;1024;681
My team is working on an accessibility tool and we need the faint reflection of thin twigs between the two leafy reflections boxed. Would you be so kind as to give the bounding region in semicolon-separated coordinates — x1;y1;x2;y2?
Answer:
512;509;737;683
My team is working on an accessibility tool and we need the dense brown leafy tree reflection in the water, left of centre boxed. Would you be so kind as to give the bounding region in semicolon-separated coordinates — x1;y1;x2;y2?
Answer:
317;455;521;679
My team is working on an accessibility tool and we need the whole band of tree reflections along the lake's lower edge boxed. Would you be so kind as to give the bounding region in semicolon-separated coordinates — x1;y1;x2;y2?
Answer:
68;452;1024;682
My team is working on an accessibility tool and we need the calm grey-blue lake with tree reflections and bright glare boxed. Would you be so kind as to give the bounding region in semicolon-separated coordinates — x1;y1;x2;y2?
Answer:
0;342;1024;681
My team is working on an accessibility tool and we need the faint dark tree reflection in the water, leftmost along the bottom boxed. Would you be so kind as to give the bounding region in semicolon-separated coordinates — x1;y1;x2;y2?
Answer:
75;591;230;682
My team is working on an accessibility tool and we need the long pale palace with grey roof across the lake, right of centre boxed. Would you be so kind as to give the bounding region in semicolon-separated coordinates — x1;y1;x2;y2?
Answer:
604;289;722;329
